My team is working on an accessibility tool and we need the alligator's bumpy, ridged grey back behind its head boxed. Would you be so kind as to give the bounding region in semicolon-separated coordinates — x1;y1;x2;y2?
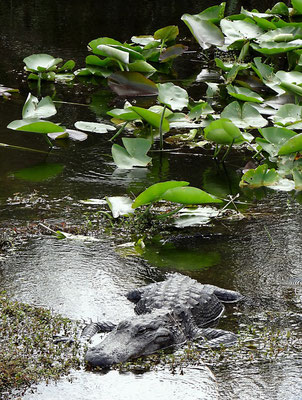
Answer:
132;274;224;328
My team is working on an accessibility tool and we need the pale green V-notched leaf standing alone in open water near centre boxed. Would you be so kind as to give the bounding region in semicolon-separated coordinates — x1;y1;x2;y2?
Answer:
111;138;152;169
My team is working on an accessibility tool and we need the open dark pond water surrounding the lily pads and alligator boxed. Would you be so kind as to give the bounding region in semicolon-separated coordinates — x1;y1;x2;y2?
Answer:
0;0;302;400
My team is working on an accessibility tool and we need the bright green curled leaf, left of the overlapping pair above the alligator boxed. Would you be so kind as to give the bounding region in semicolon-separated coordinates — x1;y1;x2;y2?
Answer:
132;181;189;208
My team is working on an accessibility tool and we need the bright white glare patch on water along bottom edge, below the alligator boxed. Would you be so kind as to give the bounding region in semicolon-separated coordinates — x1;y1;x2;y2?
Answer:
23;366;218;400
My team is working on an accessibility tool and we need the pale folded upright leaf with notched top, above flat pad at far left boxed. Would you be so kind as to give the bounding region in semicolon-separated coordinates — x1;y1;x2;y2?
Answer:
22;93;57;119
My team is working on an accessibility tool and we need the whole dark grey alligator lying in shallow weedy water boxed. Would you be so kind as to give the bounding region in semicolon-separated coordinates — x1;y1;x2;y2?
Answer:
82;273;243;368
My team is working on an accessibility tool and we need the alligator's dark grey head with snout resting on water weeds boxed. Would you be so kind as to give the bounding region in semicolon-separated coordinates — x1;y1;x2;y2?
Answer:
85;310;186;368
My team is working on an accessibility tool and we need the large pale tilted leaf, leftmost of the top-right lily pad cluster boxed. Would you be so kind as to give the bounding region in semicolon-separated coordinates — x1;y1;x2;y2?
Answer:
181;13;224;49
